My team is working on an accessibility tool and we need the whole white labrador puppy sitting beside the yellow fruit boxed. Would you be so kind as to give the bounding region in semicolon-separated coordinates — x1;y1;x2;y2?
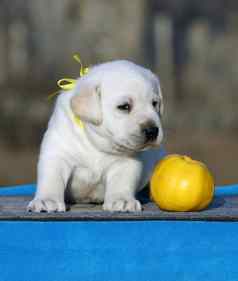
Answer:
28;61;163;212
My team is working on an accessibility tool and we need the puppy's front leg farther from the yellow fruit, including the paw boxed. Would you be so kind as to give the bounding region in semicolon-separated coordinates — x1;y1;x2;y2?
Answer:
27;156;71;212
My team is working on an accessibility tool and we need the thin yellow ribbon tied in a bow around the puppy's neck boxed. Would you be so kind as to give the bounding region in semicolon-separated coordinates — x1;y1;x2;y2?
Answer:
48;54;89;128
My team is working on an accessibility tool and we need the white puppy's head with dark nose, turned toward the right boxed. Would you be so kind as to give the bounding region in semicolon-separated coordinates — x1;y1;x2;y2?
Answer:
71;61;163;153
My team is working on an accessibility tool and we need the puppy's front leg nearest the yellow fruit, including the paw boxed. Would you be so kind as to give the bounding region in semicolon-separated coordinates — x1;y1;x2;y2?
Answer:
103;159;142;212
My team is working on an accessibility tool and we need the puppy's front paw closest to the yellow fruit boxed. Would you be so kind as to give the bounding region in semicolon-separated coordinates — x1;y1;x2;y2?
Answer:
103;199;142;212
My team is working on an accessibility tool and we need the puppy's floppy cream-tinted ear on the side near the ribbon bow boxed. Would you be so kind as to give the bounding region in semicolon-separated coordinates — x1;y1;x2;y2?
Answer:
71;81;102;125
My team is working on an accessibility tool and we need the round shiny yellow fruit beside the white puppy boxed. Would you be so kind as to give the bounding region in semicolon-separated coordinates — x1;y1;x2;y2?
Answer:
150;154;214;211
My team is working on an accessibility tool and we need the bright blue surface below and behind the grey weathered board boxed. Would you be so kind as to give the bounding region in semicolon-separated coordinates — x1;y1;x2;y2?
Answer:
0;185;238;281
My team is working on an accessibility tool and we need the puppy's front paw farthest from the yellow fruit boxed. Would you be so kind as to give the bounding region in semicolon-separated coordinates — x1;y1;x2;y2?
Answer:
27;199;65;213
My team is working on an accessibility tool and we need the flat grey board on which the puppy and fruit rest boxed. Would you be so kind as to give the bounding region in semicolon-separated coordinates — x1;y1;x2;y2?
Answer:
0;192;238;221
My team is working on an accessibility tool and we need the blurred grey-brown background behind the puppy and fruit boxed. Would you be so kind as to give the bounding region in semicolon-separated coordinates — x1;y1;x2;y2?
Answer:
0;0;238;185
